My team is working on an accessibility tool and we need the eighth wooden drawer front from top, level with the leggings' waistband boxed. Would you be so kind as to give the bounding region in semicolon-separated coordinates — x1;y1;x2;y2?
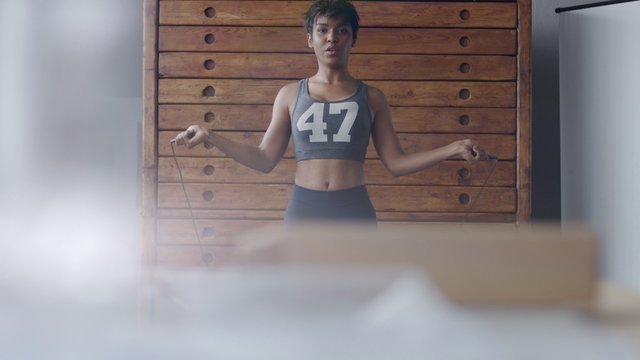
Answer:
158;183;516;213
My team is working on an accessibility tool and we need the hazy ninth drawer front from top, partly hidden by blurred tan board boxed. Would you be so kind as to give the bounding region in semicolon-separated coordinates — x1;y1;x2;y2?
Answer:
156;219;280;245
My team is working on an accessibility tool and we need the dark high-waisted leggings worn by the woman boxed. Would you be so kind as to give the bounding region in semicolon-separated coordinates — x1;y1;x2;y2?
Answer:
284;185;376;224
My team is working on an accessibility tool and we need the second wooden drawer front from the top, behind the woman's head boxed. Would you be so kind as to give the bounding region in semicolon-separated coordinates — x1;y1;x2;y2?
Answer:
158;26;517;55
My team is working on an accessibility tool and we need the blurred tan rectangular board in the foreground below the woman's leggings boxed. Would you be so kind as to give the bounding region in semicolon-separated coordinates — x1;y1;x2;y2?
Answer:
236;224;598;309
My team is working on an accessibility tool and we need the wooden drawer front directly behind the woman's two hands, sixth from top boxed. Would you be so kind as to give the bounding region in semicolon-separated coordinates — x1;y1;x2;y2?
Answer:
158;131;516;160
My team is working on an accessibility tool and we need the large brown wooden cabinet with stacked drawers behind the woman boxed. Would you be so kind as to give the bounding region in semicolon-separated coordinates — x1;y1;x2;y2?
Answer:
143;0;531;265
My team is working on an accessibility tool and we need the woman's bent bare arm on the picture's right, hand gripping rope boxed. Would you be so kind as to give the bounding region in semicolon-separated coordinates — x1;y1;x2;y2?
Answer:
368;88;487;176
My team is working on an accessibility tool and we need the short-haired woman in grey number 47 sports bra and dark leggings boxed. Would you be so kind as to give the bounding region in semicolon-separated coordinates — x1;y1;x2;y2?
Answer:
172;0;487;222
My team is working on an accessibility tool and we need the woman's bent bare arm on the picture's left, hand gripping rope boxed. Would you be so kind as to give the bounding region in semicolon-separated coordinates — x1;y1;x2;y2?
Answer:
172;83;298;173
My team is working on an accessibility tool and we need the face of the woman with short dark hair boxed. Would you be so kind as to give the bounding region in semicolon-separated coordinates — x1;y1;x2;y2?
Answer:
307;16;355;67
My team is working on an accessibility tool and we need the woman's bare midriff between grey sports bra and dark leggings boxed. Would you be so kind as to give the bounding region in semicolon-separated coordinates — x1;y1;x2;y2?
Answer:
295;159;364;191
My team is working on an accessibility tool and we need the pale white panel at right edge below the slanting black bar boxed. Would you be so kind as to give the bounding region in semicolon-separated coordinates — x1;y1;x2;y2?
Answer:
560;2;640;291
